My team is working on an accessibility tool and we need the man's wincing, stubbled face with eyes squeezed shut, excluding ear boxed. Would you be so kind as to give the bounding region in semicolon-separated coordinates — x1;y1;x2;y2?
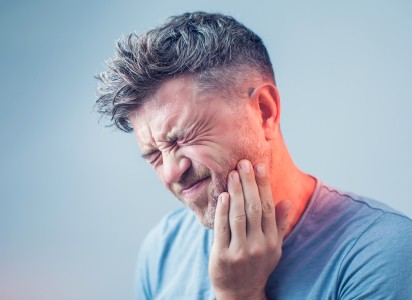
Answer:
129;76;271;228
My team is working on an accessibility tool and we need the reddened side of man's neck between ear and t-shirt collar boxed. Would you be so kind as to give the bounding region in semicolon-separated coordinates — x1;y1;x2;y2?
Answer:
271;137;316;236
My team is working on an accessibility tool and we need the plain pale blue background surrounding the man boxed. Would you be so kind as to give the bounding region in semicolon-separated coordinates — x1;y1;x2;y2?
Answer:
0;0;412;300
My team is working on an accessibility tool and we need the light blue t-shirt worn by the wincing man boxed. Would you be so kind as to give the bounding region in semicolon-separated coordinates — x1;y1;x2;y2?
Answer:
136;180;412;300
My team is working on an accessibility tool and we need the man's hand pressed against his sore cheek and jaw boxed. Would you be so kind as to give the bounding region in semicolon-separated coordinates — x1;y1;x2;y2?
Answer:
209;160;290;300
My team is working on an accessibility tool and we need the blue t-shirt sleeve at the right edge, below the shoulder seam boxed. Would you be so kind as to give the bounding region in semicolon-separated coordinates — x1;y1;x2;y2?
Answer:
338;213;412;300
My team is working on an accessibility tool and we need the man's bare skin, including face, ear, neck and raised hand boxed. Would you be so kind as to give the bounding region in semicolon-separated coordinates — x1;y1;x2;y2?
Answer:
129;76;315;299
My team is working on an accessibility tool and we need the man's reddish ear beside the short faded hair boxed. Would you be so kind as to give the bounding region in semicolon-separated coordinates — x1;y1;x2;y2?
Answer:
251;83;280;141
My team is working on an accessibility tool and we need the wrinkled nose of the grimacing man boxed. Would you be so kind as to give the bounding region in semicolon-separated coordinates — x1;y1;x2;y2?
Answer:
163;152;191;185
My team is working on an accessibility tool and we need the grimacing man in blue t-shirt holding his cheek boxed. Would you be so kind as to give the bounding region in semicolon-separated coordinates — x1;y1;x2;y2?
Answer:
97;12;412;299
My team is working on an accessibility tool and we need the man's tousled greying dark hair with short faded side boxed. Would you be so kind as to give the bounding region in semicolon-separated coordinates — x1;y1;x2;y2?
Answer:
95;12;275;132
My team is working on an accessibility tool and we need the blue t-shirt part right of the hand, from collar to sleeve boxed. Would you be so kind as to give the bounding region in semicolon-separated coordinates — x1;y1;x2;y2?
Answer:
269;181;412;299
